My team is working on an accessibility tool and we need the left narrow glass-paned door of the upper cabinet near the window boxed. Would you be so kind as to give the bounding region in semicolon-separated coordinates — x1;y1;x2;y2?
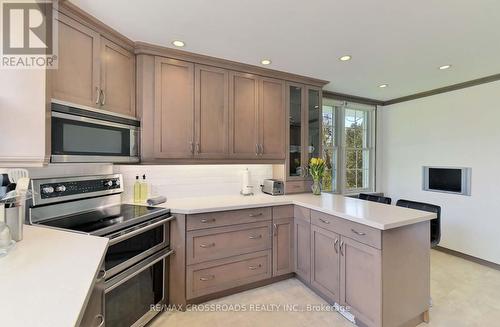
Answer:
286;83;305;180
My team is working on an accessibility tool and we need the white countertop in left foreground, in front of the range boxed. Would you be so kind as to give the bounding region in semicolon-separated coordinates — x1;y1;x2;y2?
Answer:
0;225;108;327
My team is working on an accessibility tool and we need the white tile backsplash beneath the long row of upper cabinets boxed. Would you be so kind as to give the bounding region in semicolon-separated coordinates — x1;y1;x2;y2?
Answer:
113;164;273;201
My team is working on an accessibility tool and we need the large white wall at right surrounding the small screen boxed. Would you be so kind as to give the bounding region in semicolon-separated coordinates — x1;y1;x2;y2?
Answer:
378;82;500;263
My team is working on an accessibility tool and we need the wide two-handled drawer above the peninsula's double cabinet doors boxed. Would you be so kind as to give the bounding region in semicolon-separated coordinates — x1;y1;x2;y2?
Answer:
311;210;382;249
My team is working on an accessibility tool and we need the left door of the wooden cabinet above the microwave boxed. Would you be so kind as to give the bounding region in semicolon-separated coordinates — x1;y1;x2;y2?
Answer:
51;13;100;108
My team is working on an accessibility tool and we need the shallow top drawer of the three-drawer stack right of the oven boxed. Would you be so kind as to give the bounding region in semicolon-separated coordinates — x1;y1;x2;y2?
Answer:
186;207;271;231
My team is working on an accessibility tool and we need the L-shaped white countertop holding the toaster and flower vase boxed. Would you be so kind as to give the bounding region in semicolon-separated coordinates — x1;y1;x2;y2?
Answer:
162;193;436;230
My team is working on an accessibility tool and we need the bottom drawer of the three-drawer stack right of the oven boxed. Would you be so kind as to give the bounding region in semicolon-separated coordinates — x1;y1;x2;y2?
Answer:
186;250;271;299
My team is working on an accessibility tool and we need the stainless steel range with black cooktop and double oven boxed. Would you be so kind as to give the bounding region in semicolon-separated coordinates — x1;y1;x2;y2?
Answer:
26;174;174;327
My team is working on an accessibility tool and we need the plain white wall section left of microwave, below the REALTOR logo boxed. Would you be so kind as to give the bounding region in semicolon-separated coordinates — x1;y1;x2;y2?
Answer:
0;69;46;167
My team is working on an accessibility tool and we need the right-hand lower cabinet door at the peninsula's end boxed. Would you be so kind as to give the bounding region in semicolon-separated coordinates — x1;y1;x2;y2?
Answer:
340;237;382;326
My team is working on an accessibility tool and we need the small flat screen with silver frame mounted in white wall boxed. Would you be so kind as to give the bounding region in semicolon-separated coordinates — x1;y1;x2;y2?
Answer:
423;166;471;195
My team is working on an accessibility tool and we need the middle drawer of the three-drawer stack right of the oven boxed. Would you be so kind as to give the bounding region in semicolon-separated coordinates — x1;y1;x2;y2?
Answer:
186;221;272;265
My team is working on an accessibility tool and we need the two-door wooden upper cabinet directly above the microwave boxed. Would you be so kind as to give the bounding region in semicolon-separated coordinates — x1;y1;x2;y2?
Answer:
51;13;135;116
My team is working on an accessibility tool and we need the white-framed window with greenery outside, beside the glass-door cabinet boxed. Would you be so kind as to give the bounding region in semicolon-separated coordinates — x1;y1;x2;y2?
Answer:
323;99;375;193
